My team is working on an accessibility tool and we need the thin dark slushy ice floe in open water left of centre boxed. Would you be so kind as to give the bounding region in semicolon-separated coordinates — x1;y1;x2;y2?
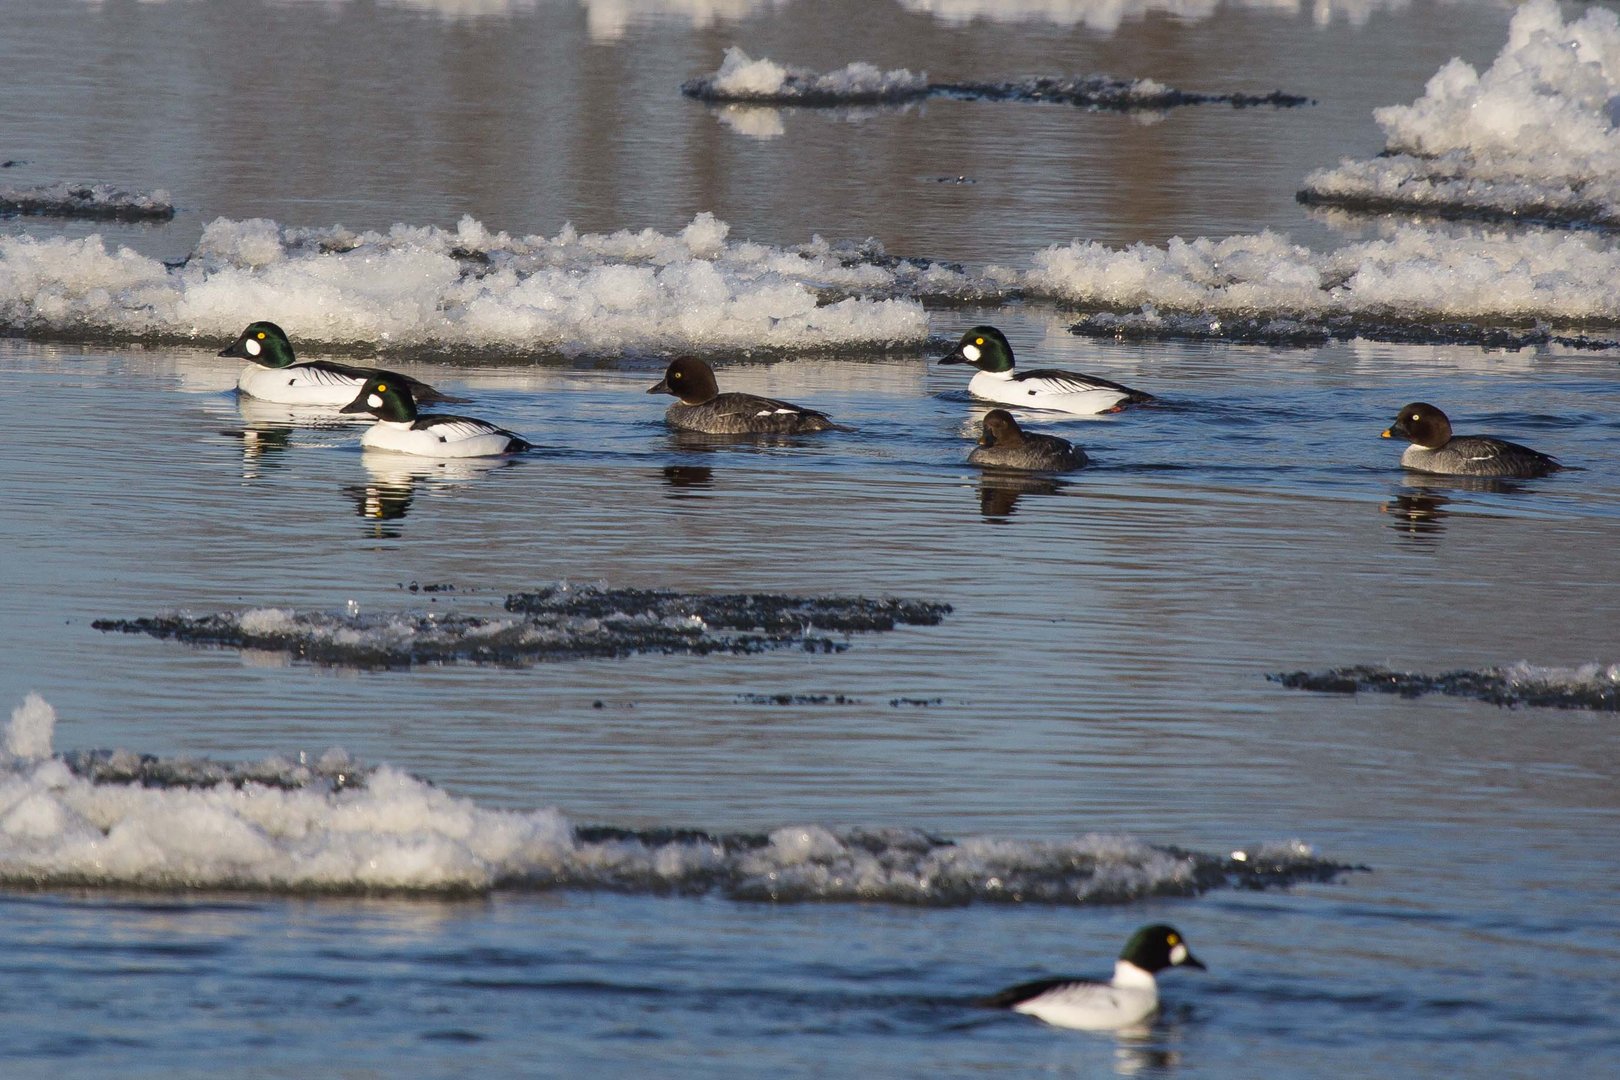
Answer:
91;585;951;669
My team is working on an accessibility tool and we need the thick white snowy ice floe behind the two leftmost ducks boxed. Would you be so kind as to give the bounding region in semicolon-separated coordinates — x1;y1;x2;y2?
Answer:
0;214;946;353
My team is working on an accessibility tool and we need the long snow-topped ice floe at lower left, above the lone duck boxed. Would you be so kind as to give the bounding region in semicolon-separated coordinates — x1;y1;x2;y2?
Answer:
0;695;1356;905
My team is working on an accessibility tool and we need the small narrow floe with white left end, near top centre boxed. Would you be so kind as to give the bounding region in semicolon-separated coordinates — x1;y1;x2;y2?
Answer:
680;47;1311;110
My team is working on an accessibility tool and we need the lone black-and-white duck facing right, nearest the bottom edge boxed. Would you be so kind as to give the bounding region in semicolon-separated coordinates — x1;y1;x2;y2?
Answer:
980;923;1204;1031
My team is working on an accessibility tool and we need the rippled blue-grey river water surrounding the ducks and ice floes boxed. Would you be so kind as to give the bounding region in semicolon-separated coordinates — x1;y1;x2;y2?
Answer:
0;0;1620;1077
